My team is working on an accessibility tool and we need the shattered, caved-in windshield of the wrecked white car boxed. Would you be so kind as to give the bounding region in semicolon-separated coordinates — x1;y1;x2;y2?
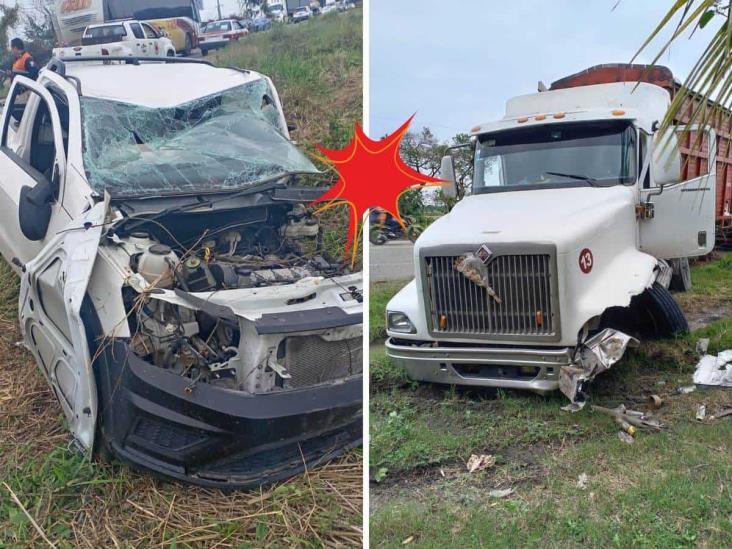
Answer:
81;79;318;197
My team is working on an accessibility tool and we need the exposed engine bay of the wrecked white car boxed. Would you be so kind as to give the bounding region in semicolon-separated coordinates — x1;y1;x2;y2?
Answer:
110;199;362;393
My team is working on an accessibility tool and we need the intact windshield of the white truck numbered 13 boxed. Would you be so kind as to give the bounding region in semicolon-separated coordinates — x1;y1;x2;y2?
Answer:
473;121;637;193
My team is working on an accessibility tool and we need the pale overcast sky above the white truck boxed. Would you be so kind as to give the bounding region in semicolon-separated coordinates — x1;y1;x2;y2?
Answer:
369;0;718;139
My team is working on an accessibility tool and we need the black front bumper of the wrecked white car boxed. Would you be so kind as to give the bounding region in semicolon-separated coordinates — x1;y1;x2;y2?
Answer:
94;340;362;489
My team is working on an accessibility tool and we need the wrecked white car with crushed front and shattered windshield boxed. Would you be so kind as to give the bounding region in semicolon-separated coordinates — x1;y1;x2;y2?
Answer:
0;57;362;488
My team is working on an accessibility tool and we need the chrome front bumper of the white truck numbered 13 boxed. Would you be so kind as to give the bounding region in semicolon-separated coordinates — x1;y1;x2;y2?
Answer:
386;338;573;394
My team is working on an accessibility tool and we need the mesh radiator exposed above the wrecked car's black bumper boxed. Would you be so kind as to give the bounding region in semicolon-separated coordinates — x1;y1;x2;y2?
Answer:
285;336;363;389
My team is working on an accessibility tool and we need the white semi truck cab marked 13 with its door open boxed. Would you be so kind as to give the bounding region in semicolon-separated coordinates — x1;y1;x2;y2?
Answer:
386;65;716;404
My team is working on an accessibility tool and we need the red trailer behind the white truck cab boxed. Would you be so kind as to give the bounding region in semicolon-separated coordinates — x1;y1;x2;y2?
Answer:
550;63;732;244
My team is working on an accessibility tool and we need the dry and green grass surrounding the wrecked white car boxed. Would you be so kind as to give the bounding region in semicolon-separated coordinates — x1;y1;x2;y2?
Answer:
0;10;363;548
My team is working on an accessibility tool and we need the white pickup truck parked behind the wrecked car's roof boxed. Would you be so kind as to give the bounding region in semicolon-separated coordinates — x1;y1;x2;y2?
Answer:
53;21;176;59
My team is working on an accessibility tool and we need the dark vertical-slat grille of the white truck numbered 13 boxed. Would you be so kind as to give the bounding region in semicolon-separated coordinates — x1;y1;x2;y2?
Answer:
424;254;558;337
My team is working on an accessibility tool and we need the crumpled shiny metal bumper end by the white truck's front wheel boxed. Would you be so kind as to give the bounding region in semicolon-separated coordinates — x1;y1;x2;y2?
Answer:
559;328;638;403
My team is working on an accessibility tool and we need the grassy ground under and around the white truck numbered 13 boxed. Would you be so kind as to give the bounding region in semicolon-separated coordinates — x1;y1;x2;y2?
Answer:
370;256;732;547
